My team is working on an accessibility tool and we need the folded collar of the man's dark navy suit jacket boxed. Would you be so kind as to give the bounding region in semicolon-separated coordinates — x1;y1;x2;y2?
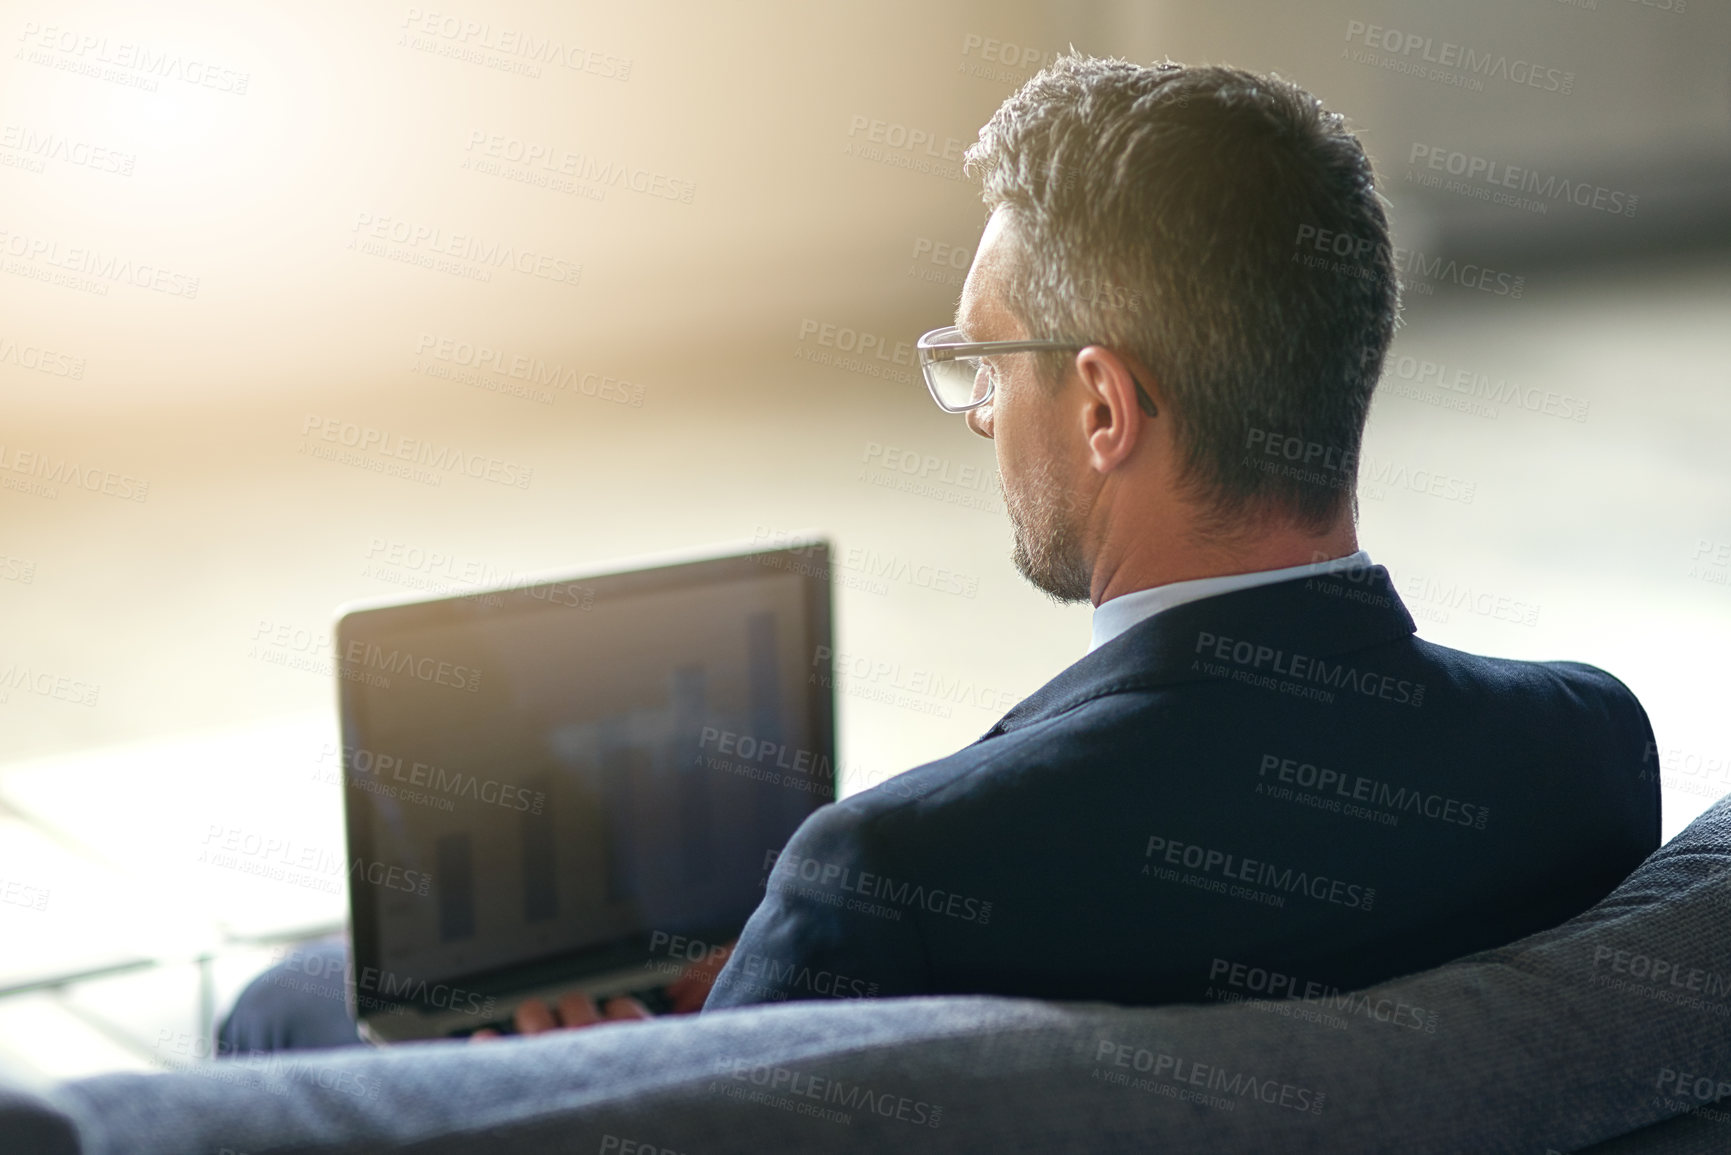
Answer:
980;566;1418;741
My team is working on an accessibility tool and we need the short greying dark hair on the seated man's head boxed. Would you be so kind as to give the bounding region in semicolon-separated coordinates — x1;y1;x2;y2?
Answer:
966;52;1399;530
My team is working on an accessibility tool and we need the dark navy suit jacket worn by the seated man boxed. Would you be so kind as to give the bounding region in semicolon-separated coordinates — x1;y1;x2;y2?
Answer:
706;566;1660;1025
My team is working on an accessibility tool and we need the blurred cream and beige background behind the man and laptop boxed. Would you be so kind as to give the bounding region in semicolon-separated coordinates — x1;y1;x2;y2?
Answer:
0;0;1731;1070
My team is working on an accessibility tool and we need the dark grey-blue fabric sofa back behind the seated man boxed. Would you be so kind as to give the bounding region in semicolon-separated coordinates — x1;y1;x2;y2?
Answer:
10;798;1731;1155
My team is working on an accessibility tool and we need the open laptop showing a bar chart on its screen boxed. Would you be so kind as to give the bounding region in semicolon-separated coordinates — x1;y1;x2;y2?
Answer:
336;539;836;1042
